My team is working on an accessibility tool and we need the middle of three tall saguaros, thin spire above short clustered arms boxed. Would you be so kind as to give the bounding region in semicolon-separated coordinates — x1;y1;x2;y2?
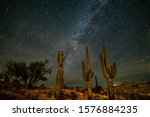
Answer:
82;47;94;99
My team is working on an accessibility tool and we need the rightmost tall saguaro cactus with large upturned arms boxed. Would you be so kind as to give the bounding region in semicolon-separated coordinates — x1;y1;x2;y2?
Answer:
100;45;116;99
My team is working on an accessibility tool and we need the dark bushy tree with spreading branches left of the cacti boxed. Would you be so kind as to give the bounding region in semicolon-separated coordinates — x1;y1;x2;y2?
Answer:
5;60;52;88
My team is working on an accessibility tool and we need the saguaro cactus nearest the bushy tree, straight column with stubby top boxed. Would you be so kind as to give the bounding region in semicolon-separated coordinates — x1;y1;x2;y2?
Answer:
55;51;65;99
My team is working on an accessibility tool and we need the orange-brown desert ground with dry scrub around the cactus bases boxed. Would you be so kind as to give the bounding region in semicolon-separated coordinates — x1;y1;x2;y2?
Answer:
0;82;150;100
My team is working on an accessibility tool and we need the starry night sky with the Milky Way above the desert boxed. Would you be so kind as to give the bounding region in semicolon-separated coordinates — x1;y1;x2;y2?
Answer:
0;0;150;86
